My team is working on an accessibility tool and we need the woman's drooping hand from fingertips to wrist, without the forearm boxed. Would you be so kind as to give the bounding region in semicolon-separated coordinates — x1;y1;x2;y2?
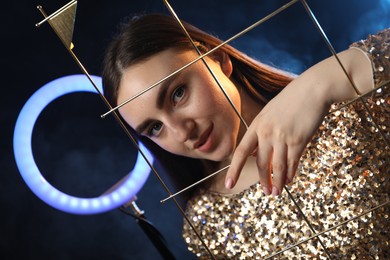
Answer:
226;76;329;195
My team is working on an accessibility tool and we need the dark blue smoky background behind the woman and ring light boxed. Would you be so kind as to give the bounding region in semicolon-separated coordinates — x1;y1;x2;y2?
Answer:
0;0;390;259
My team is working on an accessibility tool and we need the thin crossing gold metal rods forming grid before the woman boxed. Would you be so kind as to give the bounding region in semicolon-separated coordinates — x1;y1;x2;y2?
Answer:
37;0;390;259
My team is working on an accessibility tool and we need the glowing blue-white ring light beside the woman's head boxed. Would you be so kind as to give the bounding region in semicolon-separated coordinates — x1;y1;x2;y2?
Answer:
14;75;153;215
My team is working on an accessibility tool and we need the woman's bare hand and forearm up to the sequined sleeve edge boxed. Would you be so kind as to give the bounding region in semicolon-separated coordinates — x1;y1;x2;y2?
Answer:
225;49;372;195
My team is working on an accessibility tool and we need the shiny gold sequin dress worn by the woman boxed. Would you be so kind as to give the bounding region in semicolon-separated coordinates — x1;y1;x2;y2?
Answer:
183;29;390;259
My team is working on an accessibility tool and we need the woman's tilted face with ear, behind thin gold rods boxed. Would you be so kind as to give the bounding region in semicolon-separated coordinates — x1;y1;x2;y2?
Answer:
118;48;241;161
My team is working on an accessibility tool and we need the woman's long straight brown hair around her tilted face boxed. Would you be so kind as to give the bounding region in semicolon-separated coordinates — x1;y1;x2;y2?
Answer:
102;14;292;203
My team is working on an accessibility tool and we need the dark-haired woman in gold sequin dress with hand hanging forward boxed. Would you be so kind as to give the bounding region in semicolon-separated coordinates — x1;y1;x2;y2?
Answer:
103;15;390;258
